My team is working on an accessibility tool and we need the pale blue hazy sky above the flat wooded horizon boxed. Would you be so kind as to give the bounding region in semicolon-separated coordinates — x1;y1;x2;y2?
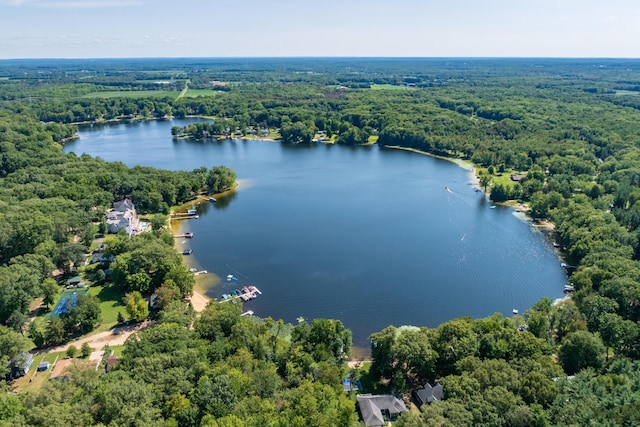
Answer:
0;0;640;59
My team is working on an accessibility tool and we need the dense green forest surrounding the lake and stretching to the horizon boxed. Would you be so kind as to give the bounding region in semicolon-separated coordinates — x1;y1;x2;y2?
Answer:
0;58;640;426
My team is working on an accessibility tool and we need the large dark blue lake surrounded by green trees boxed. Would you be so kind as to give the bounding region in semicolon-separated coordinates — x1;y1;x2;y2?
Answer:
65;119;567;347
